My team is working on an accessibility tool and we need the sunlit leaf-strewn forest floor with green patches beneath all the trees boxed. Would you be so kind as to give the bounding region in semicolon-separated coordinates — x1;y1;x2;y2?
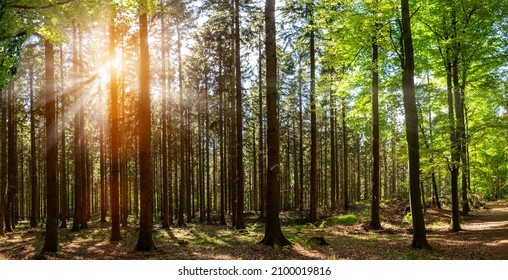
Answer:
0;202;508;260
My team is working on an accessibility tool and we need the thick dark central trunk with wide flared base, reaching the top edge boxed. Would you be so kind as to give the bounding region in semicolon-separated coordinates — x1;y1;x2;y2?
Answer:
261;0;291;247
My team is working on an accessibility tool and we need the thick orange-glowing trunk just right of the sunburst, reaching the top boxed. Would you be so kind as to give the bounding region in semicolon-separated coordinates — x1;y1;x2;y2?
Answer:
136;0;155;251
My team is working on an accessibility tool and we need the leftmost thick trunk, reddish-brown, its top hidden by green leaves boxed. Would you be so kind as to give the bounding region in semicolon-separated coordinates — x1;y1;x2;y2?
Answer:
42;40;59;253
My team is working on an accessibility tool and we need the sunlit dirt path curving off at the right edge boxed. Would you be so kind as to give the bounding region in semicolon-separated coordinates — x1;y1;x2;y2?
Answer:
463;202;508;260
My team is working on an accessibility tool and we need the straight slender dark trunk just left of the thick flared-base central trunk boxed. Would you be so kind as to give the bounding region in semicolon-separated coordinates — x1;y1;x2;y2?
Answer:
235;0;245;229
